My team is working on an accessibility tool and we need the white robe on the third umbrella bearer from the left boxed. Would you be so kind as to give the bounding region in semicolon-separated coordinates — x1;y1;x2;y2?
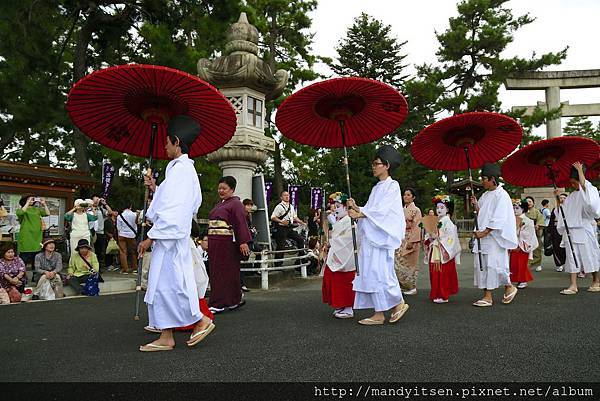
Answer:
473;186;519;290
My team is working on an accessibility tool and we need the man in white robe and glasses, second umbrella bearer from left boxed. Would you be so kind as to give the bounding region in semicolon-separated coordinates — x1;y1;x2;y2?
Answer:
348;145;408;325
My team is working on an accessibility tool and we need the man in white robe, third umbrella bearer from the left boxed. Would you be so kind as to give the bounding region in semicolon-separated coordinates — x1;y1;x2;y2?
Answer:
472;163;518;307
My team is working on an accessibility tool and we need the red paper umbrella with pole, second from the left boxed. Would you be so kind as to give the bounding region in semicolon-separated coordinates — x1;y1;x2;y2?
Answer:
275;77;408;274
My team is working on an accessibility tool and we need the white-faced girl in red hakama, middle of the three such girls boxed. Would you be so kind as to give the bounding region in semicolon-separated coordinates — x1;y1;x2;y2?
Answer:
425;195;461;304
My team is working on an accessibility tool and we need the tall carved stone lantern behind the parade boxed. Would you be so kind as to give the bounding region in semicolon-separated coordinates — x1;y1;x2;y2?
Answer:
198;13;288;199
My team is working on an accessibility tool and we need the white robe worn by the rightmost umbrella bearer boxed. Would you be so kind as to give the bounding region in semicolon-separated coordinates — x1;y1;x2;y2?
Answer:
556;181;600;273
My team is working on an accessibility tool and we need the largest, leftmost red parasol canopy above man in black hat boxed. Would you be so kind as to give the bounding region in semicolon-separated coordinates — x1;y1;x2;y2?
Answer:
67;64;236;159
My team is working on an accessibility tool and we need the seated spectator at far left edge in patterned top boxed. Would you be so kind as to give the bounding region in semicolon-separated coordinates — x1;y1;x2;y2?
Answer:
0;241;27;303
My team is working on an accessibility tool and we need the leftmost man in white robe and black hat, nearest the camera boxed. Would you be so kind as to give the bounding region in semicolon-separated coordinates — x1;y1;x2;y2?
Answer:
139;116;215;352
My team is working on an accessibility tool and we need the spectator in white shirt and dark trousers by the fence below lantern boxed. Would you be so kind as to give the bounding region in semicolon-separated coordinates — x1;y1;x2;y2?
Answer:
271;191;306;266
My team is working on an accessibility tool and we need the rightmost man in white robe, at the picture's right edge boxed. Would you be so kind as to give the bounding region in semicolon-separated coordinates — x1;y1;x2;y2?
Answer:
556;163;600;295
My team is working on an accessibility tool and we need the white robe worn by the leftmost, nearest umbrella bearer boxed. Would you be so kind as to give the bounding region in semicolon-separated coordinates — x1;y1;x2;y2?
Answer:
144;154;202;329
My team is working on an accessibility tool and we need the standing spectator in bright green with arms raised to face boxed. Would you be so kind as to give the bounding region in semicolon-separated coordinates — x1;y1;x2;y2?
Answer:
15;195;50;268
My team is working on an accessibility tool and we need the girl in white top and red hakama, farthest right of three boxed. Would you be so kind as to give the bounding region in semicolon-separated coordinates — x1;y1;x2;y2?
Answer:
510;199;539;288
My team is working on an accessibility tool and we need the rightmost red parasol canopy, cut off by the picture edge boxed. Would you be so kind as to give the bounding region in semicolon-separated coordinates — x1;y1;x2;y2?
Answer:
502;136;600;187
